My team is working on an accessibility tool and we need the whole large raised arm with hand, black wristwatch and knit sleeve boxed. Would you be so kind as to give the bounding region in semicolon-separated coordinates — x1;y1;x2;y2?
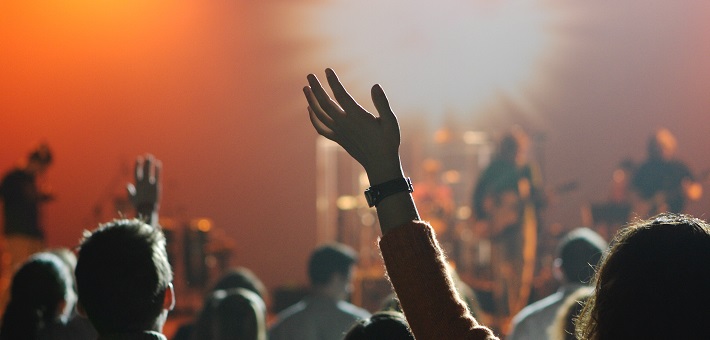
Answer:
304;69;495;340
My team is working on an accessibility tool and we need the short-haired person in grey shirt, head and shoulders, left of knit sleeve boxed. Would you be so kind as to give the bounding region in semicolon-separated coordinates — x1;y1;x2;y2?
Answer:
269;244;370;340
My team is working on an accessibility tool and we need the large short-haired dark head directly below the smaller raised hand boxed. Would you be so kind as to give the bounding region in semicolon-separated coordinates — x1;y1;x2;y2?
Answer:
76;219;173;334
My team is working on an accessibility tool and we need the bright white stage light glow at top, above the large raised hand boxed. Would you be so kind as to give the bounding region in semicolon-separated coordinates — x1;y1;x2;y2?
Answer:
302;0;564;121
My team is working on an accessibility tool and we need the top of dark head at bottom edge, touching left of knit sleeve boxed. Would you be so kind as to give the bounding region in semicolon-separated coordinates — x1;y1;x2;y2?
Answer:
343;311;414;340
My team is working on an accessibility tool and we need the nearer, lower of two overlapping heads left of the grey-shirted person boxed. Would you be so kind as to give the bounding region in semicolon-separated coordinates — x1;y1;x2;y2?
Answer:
192;288;266;340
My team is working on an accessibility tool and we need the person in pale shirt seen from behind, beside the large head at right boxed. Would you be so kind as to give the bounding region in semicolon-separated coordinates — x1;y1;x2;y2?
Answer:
508;228;607;340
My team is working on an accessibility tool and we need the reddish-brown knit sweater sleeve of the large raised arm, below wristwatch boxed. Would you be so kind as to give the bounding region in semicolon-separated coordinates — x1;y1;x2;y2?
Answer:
380;221;497;340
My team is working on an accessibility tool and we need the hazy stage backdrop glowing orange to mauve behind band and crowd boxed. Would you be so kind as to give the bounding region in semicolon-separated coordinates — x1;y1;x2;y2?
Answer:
0;0;710;322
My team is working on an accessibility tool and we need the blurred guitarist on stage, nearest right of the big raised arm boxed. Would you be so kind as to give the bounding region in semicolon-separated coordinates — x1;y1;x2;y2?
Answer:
473;127;547;328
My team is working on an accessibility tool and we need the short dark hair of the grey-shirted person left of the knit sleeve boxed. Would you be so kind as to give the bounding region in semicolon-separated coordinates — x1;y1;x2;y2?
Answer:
308;243;357;285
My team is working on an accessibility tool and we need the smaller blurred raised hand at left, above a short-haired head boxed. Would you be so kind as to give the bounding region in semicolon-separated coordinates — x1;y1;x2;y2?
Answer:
126;154;162;224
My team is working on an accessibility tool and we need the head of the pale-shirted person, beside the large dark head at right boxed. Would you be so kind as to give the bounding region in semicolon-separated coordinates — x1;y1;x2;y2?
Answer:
557;228;607;284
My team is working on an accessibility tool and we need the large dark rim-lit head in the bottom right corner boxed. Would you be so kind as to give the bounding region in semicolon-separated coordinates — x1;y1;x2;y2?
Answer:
577;213;710;339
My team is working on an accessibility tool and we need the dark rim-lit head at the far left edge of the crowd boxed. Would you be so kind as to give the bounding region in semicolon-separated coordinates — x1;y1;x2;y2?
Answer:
0;253;76;339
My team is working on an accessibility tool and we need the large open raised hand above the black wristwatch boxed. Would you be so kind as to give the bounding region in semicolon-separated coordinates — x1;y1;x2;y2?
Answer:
303;69;402;184
